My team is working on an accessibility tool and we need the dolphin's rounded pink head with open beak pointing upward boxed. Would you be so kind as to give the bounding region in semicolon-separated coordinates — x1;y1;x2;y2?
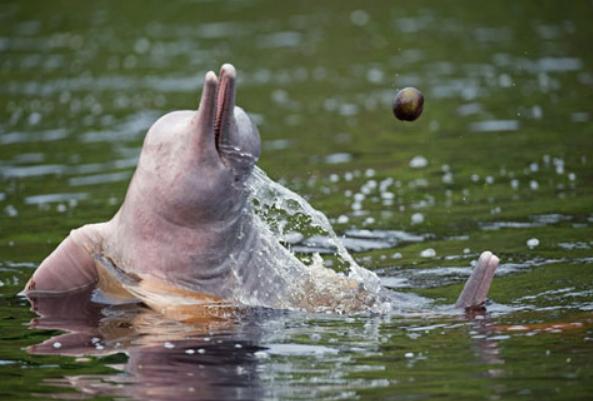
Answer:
125;64;260;225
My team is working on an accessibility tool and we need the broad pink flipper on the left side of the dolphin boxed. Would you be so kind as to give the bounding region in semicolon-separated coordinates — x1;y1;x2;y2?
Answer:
23;224;105;295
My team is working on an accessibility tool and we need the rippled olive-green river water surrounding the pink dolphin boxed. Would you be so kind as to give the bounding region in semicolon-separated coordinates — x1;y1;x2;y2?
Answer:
0;1;593;400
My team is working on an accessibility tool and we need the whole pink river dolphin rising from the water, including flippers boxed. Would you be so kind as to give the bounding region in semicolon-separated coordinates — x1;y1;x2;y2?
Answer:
24;64;498;319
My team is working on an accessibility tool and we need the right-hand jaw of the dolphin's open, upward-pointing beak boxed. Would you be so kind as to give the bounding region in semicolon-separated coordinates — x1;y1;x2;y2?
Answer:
214;64;237;150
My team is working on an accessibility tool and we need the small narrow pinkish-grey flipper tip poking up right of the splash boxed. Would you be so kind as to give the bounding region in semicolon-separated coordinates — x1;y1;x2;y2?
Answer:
455;251;499;309
